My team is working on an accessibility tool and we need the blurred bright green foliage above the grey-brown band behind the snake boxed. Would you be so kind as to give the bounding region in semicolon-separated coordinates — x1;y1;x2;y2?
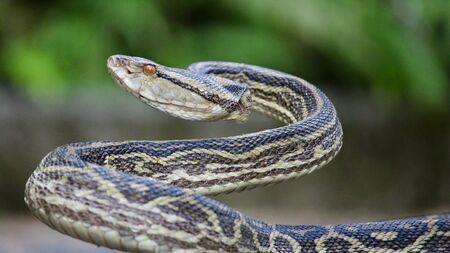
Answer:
0;0;450;109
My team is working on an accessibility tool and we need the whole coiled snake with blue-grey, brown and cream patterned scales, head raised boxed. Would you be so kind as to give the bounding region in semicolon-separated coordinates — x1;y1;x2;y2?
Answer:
25;55;450;253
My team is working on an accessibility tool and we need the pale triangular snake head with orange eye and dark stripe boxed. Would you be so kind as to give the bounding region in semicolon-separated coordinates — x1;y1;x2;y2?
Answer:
107;55;251;121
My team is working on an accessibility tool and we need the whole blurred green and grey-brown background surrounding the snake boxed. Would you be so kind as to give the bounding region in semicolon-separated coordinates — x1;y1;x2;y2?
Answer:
0;0;450;252
